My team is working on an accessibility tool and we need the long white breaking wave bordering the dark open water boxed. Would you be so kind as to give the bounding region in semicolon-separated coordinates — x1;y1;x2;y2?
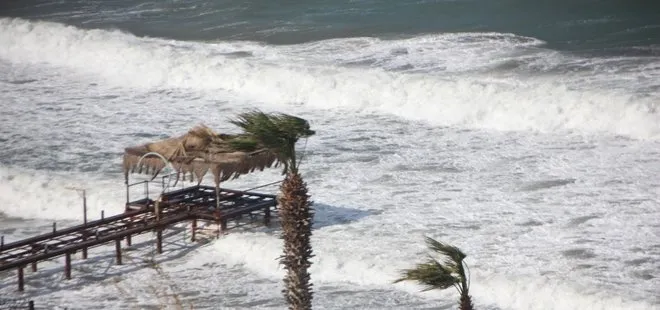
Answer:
0;18;660;138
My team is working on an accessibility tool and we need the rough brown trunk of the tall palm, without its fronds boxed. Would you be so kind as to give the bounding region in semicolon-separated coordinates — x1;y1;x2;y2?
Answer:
278;173;314;310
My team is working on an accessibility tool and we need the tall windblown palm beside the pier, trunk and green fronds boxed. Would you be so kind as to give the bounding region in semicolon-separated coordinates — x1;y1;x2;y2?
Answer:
231;111;314;310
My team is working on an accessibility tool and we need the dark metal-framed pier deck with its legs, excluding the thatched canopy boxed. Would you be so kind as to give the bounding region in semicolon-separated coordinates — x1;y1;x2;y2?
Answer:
0;185;277;291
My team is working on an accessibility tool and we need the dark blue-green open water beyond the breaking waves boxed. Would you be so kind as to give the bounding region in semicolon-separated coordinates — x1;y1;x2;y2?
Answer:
0;0;660;51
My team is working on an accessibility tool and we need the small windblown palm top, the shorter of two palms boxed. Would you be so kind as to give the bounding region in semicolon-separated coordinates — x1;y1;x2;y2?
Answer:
394;237;474;310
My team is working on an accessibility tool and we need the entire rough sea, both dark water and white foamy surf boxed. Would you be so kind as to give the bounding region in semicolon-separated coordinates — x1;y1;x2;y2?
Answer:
0;0;660;309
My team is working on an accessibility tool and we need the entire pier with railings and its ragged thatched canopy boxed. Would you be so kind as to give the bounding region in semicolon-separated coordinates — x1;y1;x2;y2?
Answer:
0;125;288;291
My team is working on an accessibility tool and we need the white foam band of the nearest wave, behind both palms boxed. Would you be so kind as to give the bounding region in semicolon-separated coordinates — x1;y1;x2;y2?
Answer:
210;230;653;310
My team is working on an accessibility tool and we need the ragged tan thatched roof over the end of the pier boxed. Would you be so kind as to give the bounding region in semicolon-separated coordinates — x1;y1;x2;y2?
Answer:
124;125;279;184
